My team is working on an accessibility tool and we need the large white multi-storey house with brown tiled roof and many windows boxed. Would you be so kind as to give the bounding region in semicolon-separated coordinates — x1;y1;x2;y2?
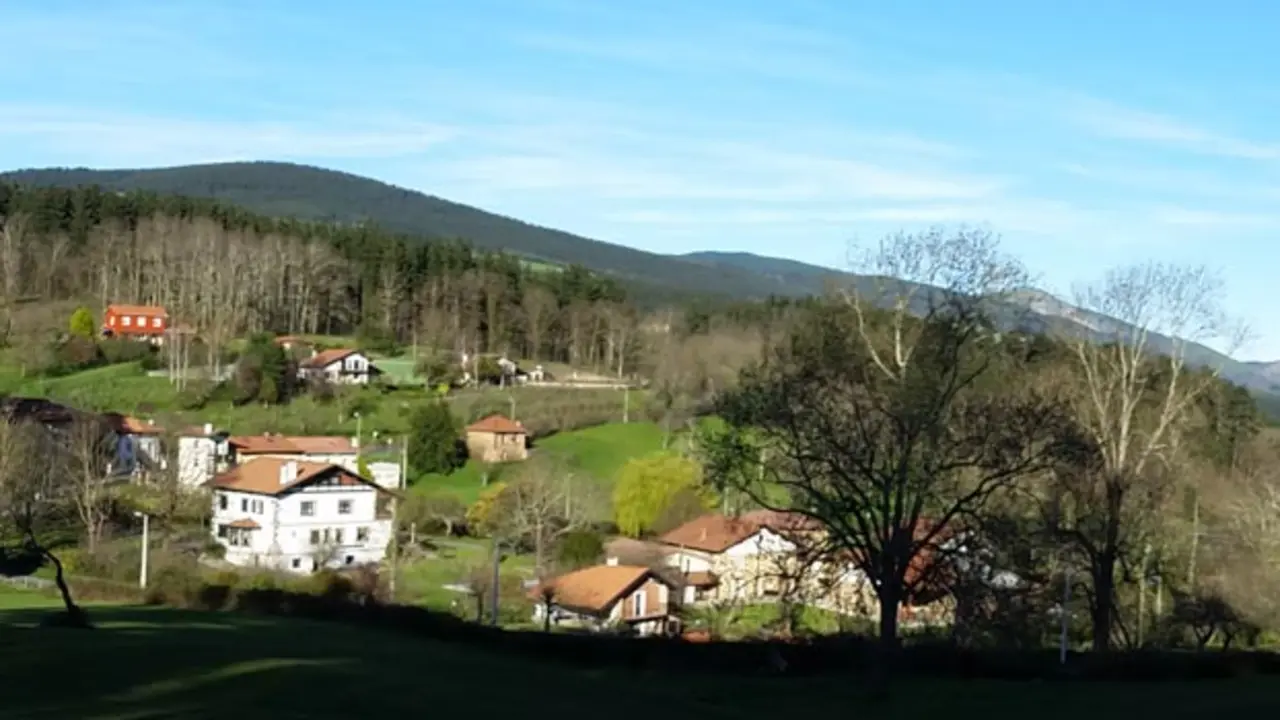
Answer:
209;457;393;573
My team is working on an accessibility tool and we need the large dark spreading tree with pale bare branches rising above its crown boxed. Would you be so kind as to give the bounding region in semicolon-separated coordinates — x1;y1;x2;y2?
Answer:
703;229;1074;652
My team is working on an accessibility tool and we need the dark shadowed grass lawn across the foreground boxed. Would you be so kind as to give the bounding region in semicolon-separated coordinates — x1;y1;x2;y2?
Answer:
0;607;1280;720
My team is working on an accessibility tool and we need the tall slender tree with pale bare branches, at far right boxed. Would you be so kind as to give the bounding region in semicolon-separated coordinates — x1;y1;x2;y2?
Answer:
1053;263;1243;651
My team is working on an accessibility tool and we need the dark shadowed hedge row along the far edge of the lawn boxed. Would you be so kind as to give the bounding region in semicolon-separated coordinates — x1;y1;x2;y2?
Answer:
55;575;1280;682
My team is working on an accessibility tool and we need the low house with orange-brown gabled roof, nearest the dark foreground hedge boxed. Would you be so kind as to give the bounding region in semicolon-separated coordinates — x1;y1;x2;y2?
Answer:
529;565;678;635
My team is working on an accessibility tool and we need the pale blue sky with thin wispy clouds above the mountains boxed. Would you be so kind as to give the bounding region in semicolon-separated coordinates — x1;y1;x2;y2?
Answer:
0;0;1280;359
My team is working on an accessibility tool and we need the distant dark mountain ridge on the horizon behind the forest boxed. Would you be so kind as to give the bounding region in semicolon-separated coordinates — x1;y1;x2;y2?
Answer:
0;161;1280;401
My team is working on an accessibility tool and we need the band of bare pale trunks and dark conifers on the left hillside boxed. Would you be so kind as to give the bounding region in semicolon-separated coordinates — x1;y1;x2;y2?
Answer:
0;179;650;368
